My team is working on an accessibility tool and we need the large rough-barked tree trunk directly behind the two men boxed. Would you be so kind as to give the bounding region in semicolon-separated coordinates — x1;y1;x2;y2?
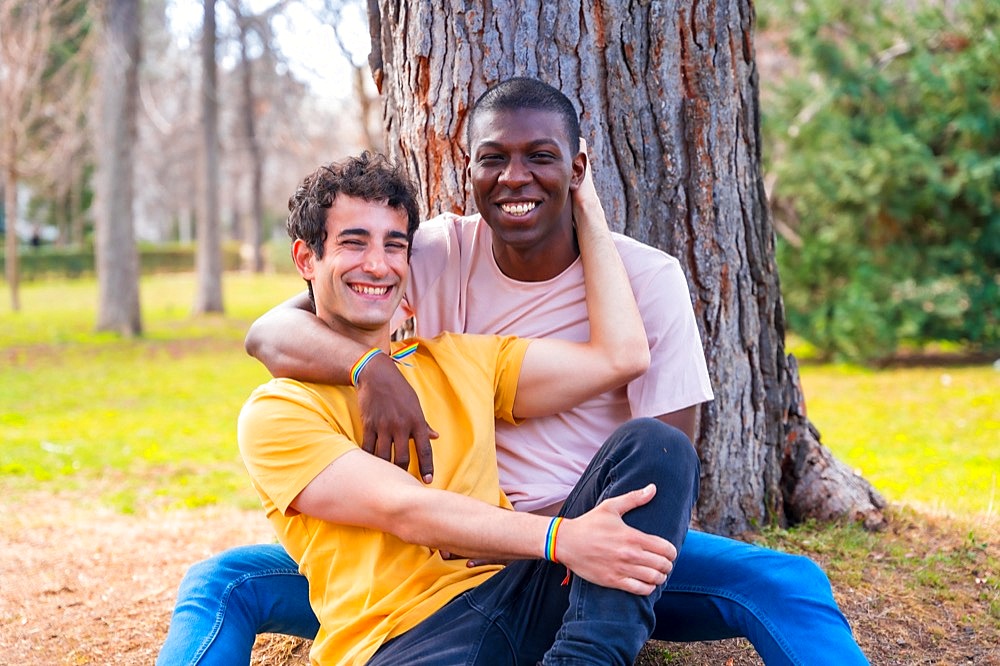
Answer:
369;0;881;534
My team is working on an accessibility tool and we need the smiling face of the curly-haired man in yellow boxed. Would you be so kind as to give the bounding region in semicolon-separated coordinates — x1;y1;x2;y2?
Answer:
292;194;409;346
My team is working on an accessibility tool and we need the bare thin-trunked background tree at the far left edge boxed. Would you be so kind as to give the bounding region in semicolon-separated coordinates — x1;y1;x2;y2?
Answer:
0;0;90;310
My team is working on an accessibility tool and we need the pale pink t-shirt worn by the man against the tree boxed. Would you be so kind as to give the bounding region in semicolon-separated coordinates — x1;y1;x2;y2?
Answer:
398;214;712;511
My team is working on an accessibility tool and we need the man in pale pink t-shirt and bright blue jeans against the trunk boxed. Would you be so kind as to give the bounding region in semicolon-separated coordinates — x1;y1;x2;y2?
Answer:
161;78;867;665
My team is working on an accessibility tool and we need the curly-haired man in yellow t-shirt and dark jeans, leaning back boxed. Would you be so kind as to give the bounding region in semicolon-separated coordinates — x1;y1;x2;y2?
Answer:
238;152;698;665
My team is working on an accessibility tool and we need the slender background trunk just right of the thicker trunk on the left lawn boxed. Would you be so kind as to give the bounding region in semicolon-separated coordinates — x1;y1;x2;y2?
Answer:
194;0;223;313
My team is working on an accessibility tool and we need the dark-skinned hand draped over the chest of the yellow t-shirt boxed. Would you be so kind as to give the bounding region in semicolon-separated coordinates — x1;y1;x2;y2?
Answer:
358;354;438;483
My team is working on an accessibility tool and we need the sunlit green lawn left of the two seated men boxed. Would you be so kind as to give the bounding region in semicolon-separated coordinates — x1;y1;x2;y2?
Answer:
0;274;302;512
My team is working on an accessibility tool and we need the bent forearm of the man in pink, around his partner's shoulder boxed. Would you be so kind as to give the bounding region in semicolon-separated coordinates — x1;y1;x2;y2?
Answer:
245;294;368;384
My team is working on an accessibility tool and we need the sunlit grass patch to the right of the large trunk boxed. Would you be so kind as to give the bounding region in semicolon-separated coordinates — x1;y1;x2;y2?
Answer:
801;365;1000;517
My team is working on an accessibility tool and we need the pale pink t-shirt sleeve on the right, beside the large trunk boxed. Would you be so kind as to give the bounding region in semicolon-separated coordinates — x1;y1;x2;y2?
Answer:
627;253;714;417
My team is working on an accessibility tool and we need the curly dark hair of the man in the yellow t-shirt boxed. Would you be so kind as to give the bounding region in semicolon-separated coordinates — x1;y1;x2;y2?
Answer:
285;151;420;259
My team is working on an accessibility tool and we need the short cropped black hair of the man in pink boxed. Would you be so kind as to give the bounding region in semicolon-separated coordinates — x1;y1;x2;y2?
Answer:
465;76;580;155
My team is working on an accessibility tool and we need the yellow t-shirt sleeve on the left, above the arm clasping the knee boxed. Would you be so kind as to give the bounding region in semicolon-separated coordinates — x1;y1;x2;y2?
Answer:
237;379;357;516
